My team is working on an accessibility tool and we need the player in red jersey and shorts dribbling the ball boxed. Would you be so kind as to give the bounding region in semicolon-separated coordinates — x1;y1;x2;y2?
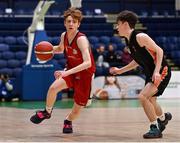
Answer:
30;8;95;133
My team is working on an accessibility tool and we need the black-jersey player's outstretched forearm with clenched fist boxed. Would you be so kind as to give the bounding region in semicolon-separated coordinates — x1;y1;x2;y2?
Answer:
110;60;138;75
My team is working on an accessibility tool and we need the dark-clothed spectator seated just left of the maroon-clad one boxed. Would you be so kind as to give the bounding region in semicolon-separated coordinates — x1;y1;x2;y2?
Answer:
106;44;121;66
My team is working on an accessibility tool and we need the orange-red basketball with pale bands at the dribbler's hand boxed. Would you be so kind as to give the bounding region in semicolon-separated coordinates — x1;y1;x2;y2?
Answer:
35;41;54;61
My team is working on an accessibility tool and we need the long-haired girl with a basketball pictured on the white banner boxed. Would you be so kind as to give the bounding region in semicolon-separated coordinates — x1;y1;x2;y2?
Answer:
94;76;127;100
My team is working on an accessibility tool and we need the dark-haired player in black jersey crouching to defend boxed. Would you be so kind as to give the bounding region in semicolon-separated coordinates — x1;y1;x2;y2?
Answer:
110;10;172;138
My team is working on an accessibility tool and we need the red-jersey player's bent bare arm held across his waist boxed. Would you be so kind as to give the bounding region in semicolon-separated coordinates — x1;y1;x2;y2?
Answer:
63;36;91;76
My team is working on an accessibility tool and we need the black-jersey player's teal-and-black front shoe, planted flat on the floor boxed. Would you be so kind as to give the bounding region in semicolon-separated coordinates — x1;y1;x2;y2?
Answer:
143;124;162;139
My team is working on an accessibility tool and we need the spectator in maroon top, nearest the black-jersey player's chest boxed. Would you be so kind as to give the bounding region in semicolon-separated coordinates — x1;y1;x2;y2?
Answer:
122;47;132;65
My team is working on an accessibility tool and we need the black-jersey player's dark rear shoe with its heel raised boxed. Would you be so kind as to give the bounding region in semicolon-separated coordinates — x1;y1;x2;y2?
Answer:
157;112;172;132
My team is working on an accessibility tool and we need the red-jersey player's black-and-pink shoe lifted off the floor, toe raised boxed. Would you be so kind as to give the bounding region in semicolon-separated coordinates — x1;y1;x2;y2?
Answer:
30;110;51;124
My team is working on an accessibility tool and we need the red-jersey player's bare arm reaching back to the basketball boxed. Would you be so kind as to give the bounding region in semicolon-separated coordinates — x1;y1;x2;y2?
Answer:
53;32;65;54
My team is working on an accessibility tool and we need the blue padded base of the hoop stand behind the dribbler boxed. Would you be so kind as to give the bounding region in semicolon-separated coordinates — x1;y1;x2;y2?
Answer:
20;30;61;101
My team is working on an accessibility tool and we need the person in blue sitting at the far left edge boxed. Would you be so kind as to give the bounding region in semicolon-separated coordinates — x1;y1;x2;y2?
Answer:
0;74;13;101
